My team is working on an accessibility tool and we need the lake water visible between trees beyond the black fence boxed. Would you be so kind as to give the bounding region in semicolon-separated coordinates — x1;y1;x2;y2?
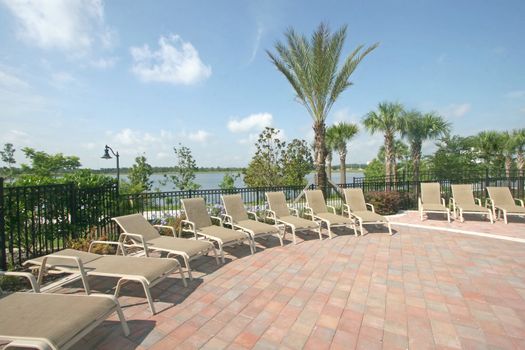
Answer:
121;171;363;192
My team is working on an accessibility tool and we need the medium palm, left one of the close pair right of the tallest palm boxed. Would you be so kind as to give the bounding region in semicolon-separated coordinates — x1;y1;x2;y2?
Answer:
363;102;403;182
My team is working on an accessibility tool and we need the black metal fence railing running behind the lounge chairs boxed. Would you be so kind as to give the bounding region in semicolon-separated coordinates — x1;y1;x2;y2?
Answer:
0;174;525;269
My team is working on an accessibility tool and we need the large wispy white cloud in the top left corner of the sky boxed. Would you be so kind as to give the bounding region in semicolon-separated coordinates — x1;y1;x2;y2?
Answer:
2;0;114;55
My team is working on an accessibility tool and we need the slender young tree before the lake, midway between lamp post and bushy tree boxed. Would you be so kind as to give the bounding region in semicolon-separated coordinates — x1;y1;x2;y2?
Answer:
163;143;201;191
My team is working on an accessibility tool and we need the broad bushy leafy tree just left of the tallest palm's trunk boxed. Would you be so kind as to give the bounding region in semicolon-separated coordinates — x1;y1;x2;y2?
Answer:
243;127;312;187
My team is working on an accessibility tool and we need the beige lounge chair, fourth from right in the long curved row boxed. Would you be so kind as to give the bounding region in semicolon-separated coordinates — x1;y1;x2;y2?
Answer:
221;194;284;246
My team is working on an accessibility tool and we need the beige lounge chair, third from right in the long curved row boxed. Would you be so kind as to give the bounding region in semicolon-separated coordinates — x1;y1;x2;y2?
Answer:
266;192;323;244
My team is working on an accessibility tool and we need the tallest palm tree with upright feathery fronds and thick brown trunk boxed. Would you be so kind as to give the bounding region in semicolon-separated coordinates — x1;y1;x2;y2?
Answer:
266;23;378;191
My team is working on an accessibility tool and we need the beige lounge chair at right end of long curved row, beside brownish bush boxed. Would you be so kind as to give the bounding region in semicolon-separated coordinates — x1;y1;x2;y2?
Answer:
343;188;392;235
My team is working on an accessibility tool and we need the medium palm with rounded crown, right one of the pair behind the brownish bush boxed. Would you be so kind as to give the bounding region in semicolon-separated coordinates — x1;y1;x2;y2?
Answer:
401;111;450;181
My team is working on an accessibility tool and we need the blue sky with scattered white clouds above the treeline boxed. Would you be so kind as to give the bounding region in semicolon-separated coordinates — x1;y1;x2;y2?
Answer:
0;0;525;169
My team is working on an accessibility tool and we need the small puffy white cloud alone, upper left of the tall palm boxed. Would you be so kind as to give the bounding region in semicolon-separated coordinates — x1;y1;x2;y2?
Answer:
130;35;211;85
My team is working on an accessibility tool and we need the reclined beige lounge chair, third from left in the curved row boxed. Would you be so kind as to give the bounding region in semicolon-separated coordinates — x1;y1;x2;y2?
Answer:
112;214;219;280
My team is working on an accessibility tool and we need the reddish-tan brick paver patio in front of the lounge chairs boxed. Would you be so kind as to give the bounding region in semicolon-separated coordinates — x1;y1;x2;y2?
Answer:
5;217;525;349
